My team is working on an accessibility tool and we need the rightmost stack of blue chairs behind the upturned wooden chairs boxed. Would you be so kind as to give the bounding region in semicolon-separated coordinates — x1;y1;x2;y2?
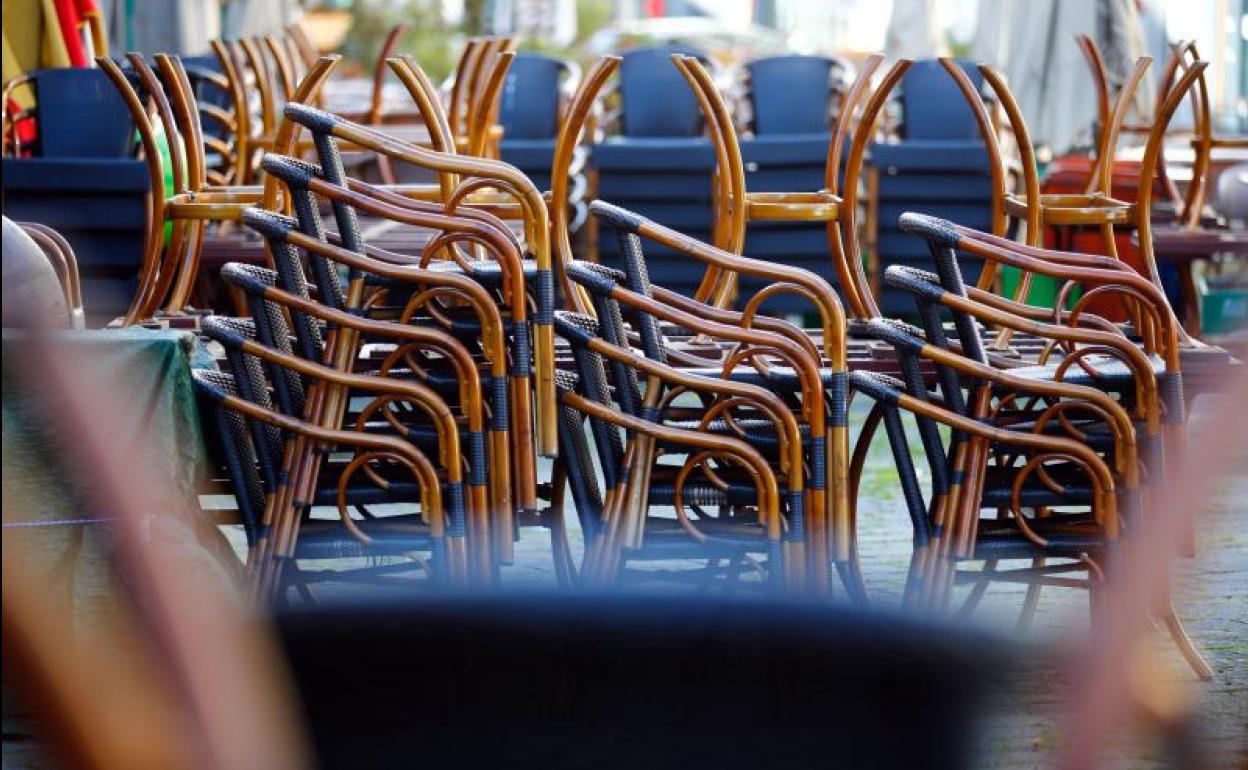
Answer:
867;60;992;317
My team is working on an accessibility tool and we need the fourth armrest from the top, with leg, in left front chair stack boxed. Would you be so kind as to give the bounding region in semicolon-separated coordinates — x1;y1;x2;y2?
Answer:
222;266;496;575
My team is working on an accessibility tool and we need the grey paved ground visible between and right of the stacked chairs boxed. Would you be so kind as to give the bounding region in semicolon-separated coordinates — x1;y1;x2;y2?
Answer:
2;404;1248;770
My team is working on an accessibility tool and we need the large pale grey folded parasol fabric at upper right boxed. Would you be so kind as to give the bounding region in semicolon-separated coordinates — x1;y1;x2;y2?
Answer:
971;0;1161;154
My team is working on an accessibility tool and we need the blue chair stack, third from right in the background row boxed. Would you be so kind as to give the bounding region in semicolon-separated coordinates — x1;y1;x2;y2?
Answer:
592;46;715;296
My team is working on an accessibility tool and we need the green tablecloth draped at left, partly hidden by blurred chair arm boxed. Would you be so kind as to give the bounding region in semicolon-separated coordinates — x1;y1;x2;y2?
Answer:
2;329;230;756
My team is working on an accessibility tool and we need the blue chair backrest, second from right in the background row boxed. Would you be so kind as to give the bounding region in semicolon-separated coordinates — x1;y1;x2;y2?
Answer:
746;55;840;135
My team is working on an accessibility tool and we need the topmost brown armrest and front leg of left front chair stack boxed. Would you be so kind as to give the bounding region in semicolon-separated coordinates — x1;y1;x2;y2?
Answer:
280;104;558;457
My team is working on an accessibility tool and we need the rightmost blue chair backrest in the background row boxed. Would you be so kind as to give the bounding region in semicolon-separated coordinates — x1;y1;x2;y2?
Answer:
901;59;983;141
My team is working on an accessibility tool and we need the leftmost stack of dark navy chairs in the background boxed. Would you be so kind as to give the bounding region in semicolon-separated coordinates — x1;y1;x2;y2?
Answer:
4;69;151;326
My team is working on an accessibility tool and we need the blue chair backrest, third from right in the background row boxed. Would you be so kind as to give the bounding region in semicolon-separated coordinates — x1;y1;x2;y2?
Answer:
620;45;708;136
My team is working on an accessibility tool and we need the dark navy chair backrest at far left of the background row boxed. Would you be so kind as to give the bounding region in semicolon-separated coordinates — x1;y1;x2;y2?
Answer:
34;67;135;157
